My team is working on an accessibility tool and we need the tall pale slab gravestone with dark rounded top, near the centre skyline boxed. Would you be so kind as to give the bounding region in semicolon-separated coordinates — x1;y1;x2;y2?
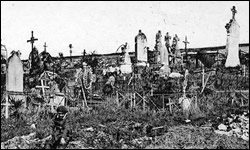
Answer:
135;30;148;62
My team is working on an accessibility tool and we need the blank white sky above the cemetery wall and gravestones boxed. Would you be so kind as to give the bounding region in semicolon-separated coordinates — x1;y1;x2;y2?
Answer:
1;1;249;59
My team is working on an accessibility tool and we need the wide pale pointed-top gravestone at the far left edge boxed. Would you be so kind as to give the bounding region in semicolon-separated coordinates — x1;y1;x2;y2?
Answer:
6;51;24;100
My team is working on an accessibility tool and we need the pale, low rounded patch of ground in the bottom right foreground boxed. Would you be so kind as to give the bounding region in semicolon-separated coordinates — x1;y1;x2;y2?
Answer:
146;125;249;149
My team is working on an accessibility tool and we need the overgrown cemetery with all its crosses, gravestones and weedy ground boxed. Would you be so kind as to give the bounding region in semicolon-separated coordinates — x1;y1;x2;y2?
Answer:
1;5;249;149
